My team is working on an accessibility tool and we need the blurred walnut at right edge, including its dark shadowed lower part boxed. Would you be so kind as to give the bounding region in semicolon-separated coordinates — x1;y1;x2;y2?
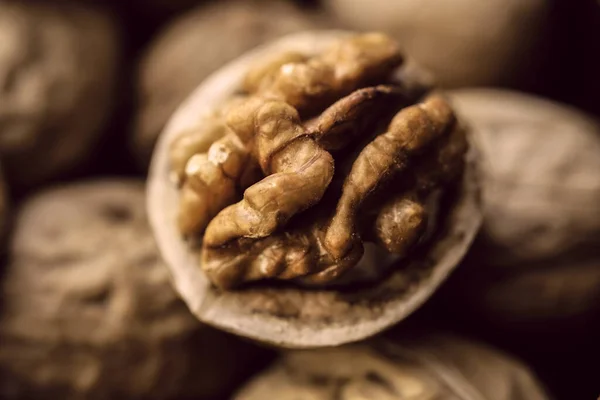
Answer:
440;89;600;340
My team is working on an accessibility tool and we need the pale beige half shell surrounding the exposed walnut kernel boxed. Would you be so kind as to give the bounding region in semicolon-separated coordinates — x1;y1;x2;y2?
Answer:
147;31;482;348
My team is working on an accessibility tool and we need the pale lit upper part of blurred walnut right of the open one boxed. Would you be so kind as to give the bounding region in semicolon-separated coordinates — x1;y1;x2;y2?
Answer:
448;89;600;264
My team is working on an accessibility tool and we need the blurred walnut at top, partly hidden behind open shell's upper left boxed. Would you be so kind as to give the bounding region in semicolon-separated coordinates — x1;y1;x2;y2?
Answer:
131;0;326;166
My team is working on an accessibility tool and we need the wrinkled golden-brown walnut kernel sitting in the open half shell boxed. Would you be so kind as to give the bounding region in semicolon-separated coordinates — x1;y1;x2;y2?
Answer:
170;33;468;289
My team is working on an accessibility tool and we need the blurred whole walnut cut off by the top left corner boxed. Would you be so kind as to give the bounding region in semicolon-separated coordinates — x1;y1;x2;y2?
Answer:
0;1;119;185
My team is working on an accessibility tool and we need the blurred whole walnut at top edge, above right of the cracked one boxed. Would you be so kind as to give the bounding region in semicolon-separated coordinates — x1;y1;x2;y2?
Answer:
325;0;551;87
